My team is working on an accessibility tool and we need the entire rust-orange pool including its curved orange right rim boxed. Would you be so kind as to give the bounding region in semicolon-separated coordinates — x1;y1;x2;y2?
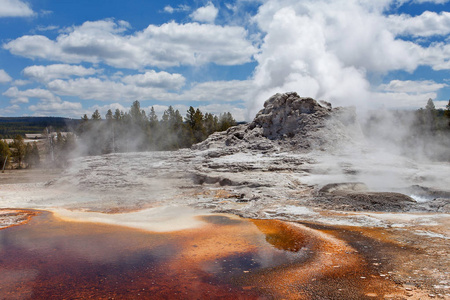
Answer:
0;212;400;299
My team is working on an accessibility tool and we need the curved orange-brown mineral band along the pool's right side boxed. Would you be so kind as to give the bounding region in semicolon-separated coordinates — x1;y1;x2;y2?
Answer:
243;220;397;299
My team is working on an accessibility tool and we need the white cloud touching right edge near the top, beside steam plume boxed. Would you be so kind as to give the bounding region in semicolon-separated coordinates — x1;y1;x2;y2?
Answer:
387;11;450;37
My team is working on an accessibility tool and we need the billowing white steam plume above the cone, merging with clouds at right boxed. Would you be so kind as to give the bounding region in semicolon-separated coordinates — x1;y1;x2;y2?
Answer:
248;0;450;118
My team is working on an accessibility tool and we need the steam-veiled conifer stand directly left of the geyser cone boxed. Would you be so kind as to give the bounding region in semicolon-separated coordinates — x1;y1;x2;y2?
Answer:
76;101;236;155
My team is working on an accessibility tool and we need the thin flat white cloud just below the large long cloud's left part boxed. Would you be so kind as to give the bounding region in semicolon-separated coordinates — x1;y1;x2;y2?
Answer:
23;64;101;82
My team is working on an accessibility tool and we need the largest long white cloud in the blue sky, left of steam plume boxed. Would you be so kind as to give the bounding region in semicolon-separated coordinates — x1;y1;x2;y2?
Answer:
3;20;257;69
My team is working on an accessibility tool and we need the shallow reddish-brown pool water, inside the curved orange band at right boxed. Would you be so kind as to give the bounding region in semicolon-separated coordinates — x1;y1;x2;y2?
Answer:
0;212;308;299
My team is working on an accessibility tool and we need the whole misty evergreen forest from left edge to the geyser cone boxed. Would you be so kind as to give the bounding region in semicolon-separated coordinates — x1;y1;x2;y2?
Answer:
0;101;236;168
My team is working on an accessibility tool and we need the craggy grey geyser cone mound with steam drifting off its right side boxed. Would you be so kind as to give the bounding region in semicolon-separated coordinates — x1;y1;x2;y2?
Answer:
194;92;362;152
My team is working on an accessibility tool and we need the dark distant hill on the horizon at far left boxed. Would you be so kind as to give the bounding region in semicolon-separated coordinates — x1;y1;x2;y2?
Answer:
0;117;80;139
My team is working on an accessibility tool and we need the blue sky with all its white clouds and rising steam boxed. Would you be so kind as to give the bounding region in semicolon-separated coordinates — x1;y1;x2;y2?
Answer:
0;0;450;121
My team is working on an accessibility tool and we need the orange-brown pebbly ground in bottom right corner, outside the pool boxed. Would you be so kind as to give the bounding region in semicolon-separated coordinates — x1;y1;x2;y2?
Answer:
303;223;450;299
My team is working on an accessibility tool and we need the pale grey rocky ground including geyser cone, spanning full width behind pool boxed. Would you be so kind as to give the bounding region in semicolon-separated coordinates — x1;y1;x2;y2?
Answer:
0;93;450;299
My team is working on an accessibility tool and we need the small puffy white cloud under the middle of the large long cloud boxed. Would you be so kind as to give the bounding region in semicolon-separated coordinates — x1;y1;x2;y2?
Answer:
122;70;186;90
